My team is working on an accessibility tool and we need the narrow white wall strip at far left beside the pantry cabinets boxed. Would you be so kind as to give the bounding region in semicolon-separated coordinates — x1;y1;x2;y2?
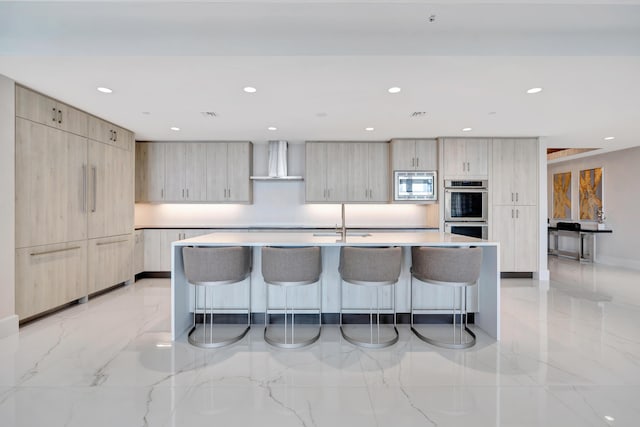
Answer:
0;75;18;338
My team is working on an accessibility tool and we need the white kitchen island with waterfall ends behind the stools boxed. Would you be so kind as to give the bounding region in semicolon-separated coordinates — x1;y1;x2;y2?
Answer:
171;231;500;340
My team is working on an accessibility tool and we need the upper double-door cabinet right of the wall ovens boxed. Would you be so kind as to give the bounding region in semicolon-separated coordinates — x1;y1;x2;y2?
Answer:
491;138;538;205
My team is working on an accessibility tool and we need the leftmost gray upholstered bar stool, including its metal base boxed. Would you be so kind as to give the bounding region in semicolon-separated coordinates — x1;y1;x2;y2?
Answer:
182;246;251;348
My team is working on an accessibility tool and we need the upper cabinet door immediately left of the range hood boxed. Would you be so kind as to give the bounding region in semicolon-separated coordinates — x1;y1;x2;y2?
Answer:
226;142;253;203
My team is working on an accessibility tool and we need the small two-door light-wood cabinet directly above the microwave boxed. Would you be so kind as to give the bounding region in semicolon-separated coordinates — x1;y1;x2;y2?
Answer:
391;139;438;172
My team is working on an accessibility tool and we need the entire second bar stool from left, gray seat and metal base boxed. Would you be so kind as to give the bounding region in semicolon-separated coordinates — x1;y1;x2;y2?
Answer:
262;246;322;348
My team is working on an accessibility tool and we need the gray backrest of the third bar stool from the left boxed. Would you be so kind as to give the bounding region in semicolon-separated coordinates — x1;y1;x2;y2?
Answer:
339;246;402;284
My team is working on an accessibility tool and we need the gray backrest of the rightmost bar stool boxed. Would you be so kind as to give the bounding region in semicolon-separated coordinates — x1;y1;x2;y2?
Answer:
411;246;482;286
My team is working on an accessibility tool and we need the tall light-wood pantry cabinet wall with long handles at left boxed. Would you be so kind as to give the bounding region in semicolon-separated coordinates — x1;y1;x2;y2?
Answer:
15;86;134;321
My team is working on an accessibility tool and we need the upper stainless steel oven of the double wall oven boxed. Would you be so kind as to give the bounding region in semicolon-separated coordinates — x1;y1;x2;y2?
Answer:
444;180;489;222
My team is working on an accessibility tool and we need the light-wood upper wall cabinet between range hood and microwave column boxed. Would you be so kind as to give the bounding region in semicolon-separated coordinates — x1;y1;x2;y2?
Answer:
305;142;389;203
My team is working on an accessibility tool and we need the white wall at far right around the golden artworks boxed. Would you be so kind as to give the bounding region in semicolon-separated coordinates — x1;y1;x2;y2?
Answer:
547;147;640;269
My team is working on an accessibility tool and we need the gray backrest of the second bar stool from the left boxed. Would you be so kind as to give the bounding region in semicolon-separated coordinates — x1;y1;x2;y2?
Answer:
262;246;322;284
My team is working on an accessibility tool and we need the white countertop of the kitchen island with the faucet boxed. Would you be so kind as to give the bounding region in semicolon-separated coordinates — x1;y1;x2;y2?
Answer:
173;230;498;246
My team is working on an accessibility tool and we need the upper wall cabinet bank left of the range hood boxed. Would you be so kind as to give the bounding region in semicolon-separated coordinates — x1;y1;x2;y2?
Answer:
136;142;253;203
